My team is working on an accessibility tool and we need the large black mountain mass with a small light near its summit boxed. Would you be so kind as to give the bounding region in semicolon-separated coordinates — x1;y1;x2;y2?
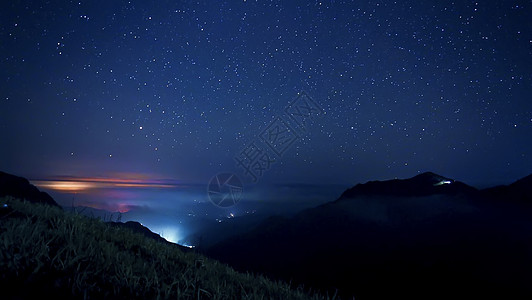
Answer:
208;173;532;299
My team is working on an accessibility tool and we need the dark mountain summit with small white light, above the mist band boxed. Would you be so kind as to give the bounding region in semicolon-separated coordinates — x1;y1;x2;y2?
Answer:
340;172;478;199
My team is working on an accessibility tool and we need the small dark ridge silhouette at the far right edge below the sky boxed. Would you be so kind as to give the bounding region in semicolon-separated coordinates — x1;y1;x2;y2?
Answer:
482;174;532;204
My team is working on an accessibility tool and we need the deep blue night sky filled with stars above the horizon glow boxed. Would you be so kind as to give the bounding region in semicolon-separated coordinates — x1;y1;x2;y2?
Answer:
0;0;532;191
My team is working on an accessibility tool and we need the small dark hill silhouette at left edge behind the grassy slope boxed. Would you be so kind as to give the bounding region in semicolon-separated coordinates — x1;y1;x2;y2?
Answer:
0;171;60;207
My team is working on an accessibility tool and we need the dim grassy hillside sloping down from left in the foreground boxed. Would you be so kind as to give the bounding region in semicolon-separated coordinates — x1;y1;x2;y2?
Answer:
0;197;332;299
